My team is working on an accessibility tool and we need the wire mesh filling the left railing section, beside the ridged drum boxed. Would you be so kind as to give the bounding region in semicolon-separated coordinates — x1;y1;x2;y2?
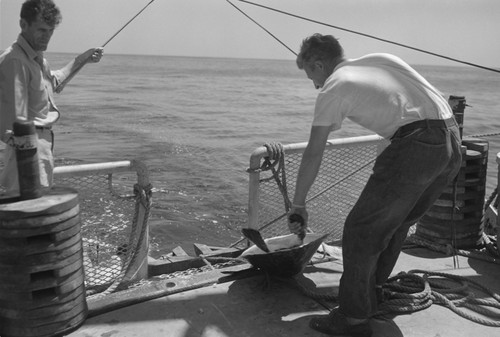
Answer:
54;174;135;291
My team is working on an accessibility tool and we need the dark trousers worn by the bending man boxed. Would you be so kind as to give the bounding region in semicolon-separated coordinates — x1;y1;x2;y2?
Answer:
339;119;462;318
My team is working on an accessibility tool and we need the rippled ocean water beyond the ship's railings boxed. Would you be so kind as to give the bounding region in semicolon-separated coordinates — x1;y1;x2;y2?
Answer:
46;53;500;256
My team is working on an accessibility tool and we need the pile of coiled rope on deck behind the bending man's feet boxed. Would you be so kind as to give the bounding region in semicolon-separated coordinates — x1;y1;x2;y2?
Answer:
376;270;500;327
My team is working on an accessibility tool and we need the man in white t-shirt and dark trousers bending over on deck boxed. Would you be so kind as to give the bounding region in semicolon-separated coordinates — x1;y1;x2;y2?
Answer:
289;34;462;337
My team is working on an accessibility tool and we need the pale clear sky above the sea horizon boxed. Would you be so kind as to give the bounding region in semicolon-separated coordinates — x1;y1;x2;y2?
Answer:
0;0;500;67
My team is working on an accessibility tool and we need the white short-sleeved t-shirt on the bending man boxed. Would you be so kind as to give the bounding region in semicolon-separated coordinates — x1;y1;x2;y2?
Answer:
312;54;453;139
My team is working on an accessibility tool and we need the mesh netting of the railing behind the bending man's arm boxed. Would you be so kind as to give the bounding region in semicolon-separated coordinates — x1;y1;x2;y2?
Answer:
249;136;383;242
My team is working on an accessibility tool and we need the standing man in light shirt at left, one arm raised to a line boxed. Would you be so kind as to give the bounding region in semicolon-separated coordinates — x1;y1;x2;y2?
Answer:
0;0;103;196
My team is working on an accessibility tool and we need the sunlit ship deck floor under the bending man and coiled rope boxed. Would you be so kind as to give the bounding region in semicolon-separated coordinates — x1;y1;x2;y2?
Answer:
69;246;500;337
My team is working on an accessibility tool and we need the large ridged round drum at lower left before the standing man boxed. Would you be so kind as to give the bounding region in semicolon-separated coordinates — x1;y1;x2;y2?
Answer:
0;188;87;337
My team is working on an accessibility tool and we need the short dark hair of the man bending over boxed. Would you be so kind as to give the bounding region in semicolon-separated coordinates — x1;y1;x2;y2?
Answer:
297;33;344;69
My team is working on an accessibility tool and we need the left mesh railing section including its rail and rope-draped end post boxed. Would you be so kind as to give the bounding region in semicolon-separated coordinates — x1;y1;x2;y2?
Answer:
54;162;151;295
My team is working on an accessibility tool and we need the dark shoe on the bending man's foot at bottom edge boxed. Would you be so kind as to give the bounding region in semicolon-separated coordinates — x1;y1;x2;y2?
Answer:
309;309;372;337
